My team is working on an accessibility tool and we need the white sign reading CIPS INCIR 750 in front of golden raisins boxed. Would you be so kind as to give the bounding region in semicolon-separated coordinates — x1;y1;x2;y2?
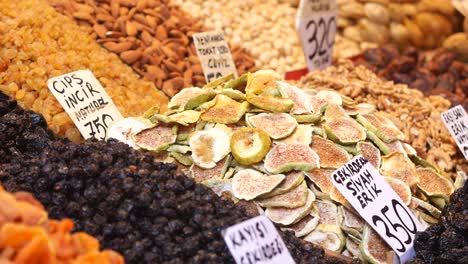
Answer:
47;70;123;139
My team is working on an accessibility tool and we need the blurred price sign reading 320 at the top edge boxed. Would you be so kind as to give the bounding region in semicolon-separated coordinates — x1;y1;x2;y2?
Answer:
296;0;338;71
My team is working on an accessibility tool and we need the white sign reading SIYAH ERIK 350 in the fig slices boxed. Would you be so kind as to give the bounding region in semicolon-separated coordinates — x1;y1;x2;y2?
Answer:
331;155;423;263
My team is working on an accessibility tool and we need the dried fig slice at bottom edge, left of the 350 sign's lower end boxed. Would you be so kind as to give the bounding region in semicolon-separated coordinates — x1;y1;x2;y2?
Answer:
359;225;392;264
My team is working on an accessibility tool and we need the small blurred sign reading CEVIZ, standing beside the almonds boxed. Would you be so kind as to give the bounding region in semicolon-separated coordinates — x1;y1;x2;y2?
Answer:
193;31;237;83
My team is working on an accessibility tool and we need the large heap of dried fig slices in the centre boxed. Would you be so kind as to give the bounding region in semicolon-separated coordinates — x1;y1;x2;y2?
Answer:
108;70;460;262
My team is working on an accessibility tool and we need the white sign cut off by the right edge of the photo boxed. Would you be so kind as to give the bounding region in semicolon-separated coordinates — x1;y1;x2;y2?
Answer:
441;105;468;160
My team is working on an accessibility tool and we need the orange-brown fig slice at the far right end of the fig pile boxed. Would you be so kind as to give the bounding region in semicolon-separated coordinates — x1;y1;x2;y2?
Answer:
416;168;455;201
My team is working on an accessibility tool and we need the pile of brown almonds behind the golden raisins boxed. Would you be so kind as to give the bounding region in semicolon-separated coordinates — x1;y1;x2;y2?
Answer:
49;0;254;96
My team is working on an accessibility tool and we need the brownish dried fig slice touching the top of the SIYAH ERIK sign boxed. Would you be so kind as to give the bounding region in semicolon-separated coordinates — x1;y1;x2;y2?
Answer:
312;136;350;169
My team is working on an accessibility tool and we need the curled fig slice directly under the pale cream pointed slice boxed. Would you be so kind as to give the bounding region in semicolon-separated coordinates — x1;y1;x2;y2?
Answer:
257;181;308;208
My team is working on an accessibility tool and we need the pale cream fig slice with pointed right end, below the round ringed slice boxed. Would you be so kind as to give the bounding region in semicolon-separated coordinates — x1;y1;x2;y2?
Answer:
232;169;285;201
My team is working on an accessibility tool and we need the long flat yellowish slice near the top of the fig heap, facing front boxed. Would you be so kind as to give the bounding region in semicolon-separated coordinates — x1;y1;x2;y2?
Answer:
246;94;294;113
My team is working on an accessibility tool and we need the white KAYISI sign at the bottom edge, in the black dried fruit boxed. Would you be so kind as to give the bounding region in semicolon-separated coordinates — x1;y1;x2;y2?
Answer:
223;215;294;264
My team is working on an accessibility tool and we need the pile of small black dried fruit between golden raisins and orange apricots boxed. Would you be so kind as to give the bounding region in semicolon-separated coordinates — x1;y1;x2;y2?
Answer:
0;94;348;263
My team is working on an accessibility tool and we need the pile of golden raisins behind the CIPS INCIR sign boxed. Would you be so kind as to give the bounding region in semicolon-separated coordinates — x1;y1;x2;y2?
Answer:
0;0;167;141
